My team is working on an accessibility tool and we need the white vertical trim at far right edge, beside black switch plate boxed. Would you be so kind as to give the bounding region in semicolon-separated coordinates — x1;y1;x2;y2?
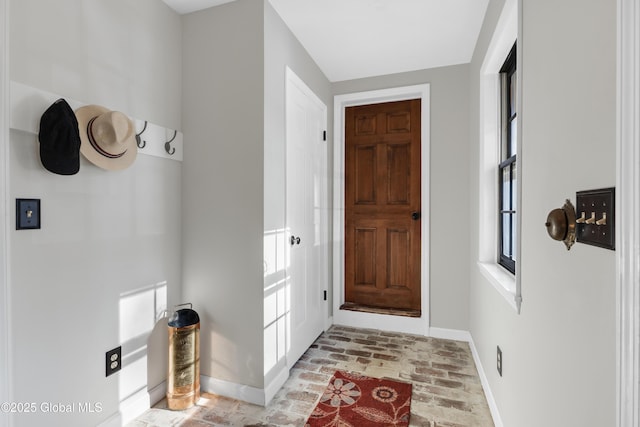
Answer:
616;0;640;427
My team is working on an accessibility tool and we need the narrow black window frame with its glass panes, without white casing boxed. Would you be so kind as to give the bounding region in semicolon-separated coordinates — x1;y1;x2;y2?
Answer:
498;44;518;274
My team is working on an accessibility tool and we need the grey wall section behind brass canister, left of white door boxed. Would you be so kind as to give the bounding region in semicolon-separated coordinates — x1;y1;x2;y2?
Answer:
182;0;264;389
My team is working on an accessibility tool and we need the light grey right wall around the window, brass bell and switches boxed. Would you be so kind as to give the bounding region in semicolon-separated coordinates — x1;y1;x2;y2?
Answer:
469;0;616;427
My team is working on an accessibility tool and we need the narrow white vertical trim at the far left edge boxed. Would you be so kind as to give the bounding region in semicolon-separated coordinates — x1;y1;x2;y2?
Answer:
0;0;13;427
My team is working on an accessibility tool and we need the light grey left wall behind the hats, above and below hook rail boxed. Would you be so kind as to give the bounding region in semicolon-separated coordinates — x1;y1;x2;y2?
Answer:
8;0;182;427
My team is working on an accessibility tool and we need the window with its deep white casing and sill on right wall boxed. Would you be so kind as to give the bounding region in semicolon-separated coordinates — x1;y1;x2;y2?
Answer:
477;0;523;313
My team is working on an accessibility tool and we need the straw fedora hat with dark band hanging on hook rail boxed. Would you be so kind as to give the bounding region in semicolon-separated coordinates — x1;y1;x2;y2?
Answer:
76;105;138;170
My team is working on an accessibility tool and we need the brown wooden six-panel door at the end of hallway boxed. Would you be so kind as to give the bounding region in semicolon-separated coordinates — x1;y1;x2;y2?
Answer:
344;99;421;316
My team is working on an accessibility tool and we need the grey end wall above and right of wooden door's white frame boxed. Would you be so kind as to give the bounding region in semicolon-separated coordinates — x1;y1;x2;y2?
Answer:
332;65;469;331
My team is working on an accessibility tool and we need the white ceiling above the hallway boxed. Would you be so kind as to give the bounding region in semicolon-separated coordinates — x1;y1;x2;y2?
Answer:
163;0;489;82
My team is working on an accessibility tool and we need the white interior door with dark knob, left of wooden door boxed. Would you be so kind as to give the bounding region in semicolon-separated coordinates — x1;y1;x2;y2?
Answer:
286;69;329;367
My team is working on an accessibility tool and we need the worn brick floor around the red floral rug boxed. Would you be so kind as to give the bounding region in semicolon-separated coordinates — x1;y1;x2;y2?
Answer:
127;326;494;427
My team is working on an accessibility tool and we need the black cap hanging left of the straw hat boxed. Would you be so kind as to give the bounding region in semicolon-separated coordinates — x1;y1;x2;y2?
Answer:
38;98;80;175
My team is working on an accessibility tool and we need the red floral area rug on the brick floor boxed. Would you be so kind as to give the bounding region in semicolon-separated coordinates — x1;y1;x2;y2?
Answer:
305;371;411;427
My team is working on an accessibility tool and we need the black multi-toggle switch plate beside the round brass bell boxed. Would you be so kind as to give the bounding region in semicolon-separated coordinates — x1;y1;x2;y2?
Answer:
576;187;616;250
